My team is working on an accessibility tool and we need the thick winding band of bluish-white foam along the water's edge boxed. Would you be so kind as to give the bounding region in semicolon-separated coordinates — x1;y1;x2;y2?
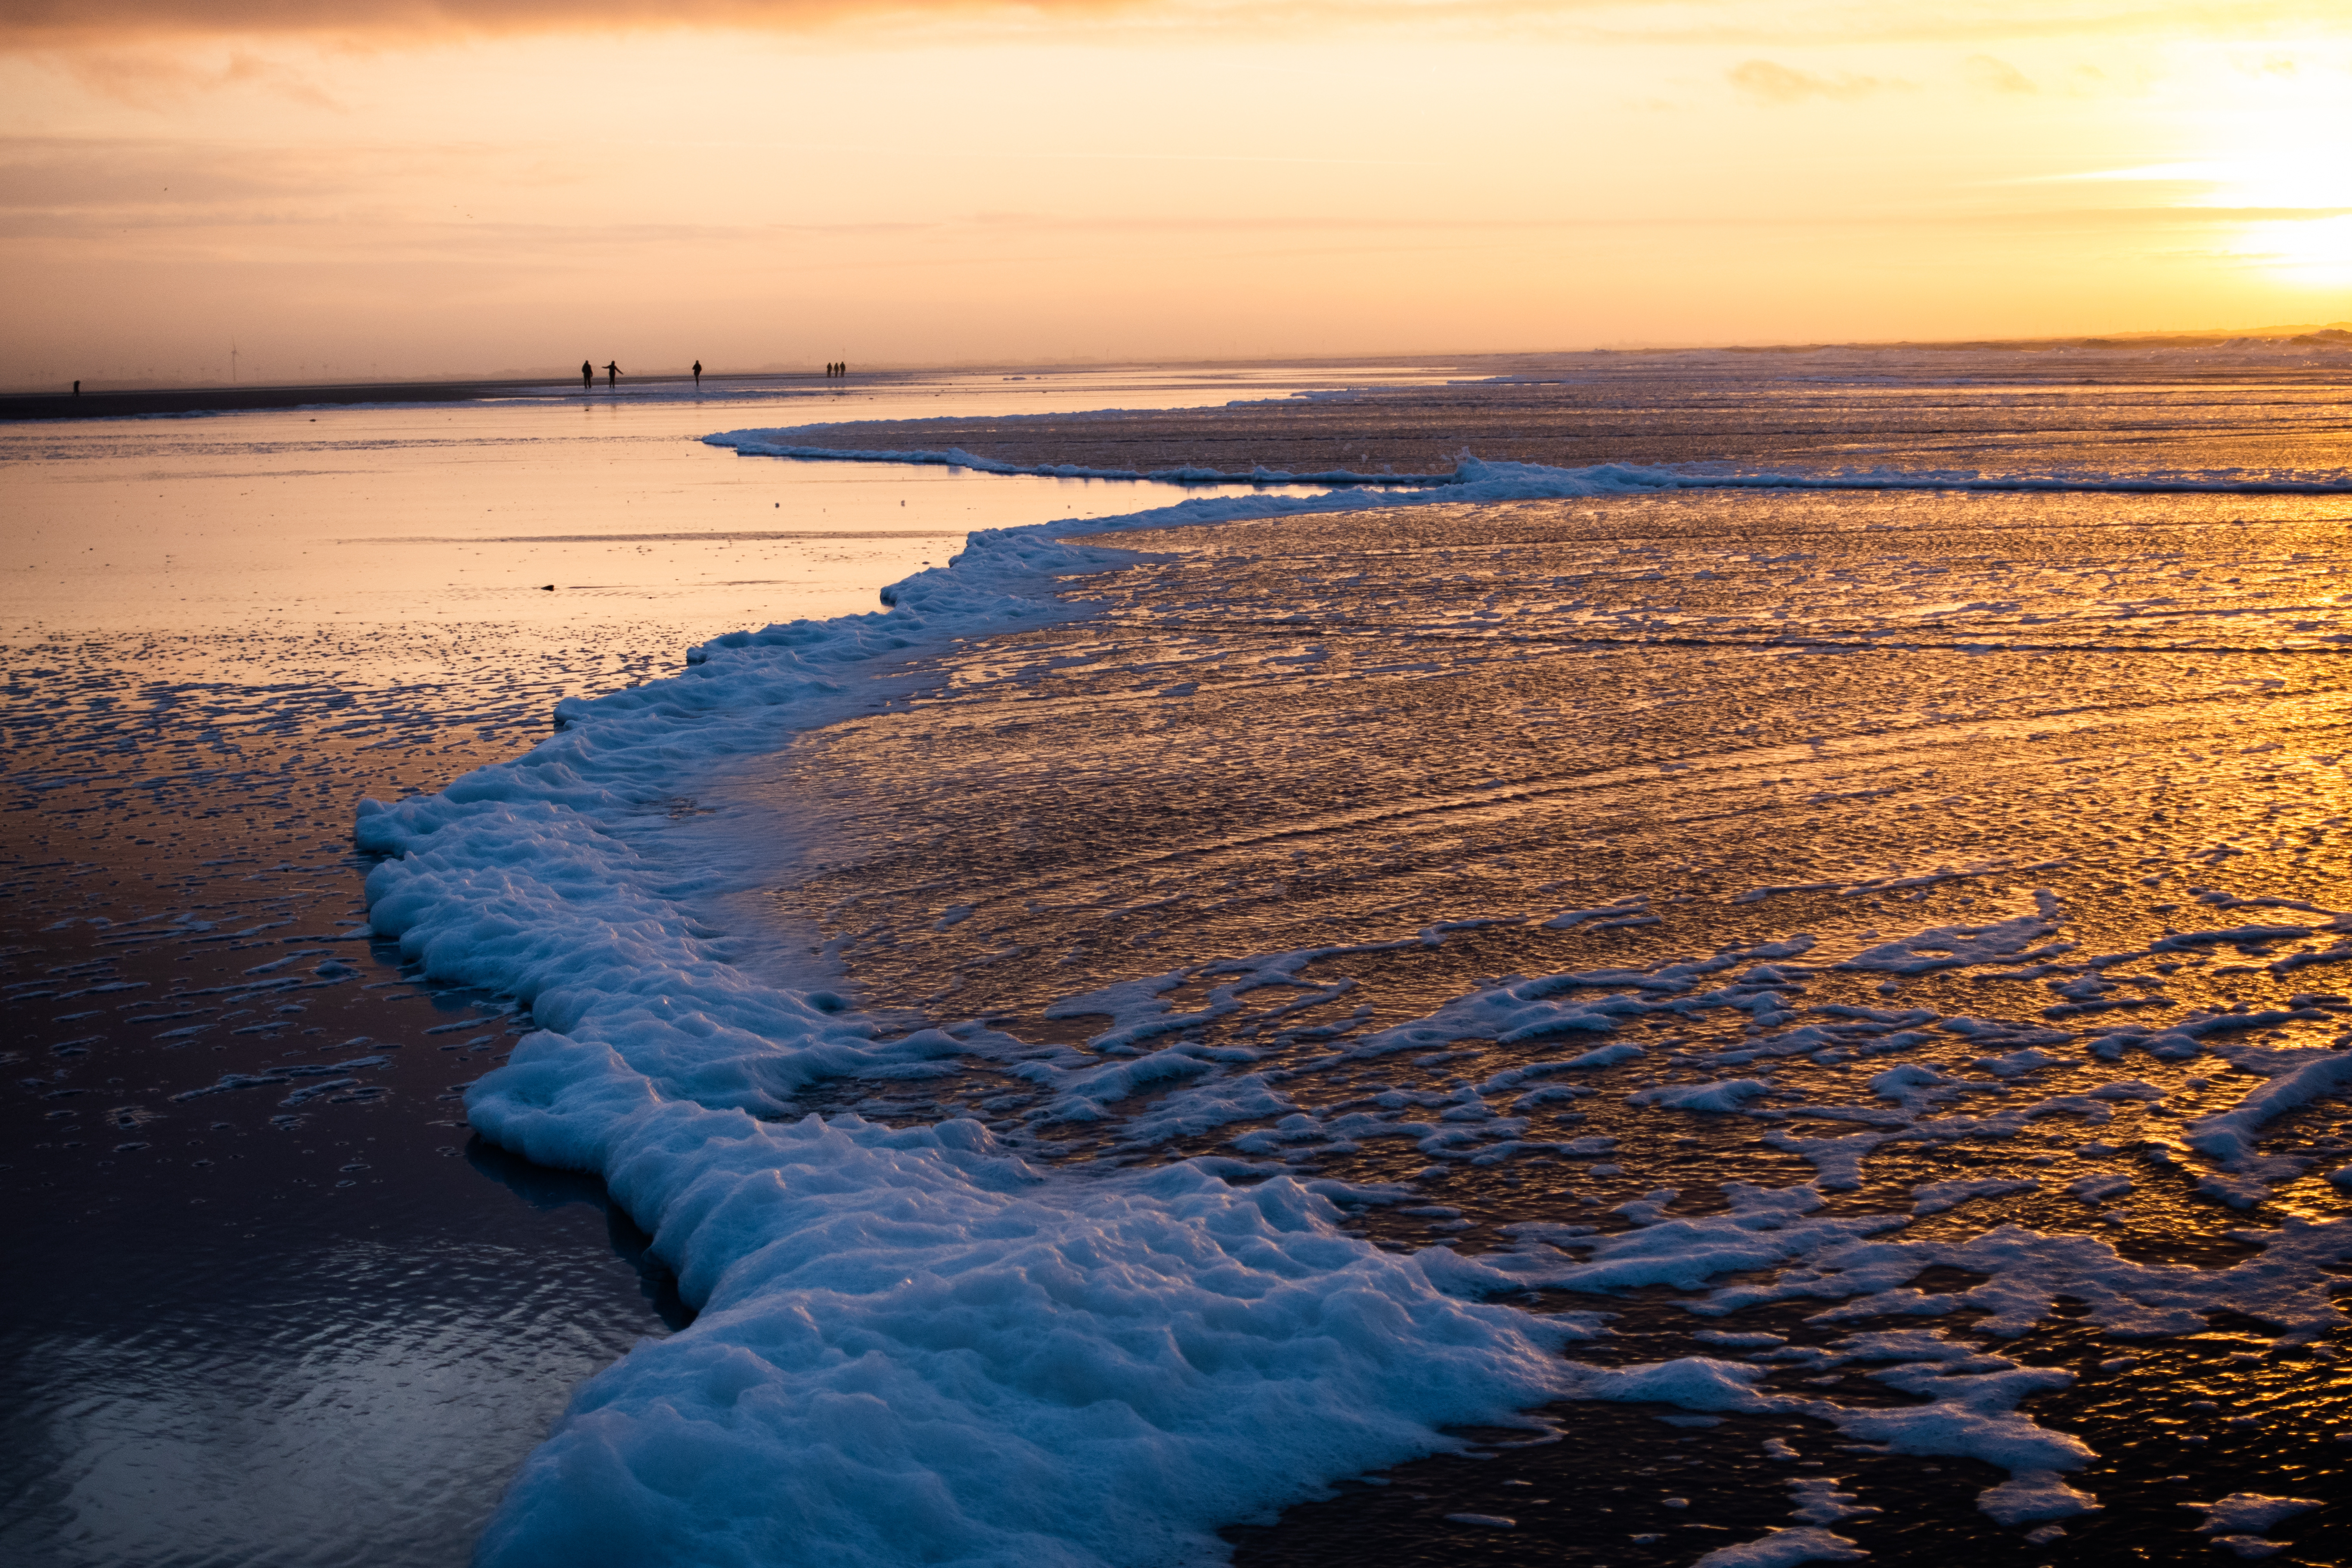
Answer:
357;465;1655;1563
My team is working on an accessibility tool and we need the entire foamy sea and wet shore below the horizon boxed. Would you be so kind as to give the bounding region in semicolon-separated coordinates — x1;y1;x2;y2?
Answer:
0;353;2352;1568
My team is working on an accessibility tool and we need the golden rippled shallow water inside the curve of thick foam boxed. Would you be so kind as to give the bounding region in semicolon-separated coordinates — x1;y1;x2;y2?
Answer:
738;491;2352;1563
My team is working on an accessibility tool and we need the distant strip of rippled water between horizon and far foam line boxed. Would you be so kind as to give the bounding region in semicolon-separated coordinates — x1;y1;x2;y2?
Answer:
743;348;2352;475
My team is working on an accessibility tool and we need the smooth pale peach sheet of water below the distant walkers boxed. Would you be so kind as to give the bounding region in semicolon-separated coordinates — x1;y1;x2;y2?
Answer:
0;364;1373;639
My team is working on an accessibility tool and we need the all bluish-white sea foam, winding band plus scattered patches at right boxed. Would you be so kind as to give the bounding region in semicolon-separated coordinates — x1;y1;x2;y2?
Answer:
348;442;2352;1566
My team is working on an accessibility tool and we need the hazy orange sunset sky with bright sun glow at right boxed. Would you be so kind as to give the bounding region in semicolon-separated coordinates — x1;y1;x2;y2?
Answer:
0;0;2352;388
